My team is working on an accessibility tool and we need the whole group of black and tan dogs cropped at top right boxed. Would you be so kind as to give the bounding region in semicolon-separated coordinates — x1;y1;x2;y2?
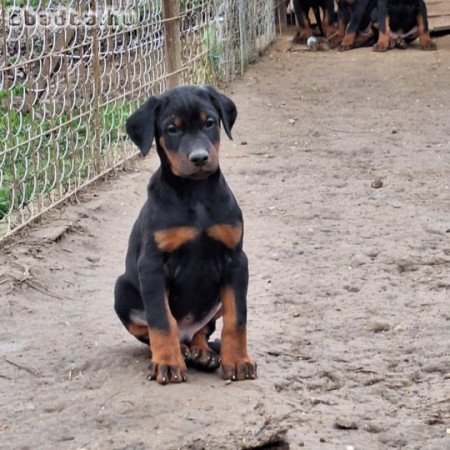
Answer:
290;0;436;52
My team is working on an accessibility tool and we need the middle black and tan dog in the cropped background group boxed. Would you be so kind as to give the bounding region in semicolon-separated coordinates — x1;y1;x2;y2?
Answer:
328;0;378;51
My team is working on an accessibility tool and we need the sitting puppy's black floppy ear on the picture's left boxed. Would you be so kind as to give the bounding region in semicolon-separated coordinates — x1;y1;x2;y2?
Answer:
126;97;159;156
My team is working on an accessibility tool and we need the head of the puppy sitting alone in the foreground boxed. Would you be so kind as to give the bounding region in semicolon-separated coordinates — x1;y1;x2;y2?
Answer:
126;86;237;180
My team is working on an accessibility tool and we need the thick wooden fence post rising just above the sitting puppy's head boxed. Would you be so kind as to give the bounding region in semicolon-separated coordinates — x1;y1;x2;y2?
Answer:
163;0;183;87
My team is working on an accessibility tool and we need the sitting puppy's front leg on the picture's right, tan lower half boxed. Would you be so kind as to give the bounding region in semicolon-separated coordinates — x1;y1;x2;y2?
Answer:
220;253;256;381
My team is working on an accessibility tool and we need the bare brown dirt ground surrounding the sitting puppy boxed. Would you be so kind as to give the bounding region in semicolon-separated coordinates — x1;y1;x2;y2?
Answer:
0;29;450;450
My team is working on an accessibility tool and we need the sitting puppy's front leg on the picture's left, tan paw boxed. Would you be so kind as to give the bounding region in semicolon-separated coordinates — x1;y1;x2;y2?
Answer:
139;255;186;384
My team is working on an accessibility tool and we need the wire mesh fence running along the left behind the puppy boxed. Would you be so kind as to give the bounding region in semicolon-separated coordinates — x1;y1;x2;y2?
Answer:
0;0;282;241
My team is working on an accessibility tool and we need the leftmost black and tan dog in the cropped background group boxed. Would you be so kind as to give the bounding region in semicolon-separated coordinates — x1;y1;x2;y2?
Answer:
293;0;336;44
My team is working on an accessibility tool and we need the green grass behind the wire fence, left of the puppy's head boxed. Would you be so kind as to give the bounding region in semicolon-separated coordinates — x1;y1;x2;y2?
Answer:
0;94;132;219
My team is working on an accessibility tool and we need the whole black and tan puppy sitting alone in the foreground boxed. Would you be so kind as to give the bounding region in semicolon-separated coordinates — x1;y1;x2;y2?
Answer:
115;86;256;384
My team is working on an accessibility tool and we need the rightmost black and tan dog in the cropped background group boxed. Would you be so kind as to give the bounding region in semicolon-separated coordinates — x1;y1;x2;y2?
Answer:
373;0;436;52
